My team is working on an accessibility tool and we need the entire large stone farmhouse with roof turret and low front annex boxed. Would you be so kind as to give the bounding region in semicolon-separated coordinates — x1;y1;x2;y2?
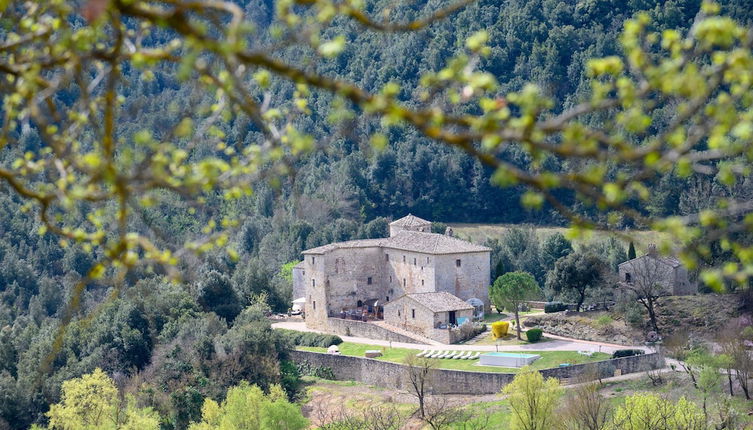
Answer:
293;214;491;341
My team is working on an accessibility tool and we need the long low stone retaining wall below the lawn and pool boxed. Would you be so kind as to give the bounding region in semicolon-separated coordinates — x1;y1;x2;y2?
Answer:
291;351;664;394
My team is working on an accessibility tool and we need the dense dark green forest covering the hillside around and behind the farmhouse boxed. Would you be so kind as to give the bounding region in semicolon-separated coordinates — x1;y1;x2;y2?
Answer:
0;0;753;429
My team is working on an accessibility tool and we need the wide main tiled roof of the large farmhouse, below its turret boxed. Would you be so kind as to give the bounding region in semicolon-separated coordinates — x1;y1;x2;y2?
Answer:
303;231;491;255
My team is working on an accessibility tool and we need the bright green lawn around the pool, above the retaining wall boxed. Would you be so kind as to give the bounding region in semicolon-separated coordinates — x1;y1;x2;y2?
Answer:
298;342;611;373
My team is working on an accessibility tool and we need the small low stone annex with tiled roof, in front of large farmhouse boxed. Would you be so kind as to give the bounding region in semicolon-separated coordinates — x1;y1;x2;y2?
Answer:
384;291;474;338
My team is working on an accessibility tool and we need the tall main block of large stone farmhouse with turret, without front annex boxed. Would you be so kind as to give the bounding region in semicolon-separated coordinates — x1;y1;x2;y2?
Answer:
293;215;491;338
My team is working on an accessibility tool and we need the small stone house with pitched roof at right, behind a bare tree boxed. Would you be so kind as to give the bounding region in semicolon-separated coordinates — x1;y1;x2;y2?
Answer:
618;245;698;296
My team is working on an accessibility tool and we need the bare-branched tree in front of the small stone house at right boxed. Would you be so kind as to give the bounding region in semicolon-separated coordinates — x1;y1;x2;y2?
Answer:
620;248;669;332
